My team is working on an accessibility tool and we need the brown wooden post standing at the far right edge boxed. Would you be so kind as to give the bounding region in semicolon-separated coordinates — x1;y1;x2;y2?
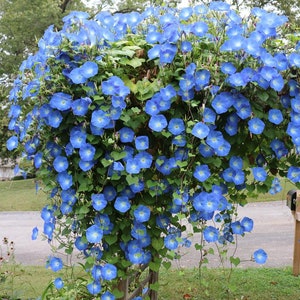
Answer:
293;190;300;276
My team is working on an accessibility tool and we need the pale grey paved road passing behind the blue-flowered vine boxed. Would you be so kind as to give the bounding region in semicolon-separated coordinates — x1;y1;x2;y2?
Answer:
0;201;295;267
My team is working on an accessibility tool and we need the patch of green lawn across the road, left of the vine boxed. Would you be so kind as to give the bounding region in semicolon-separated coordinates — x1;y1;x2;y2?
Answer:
0;179;47;211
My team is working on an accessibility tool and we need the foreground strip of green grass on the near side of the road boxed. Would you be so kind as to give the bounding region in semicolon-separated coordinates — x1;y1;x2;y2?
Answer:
0;266;300;300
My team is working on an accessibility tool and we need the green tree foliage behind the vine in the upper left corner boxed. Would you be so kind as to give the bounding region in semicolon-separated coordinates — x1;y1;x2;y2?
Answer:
0;0;83;76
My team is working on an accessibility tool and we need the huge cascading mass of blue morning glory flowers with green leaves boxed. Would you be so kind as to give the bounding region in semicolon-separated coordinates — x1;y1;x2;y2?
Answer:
7;1;300;299
